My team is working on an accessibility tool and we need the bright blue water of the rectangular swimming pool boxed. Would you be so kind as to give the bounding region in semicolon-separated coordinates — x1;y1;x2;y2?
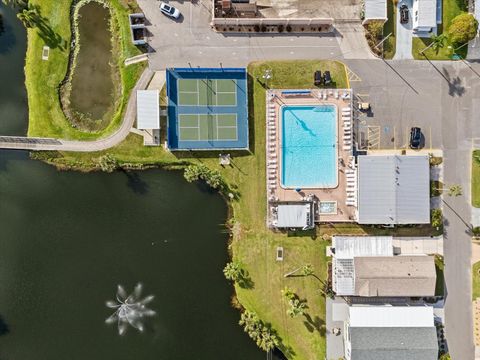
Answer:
282;105;337;188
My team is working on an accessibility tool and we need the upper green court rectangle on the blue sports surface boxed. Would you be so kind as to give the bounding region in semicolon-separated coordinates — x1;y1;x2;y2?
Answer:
178;79;237;106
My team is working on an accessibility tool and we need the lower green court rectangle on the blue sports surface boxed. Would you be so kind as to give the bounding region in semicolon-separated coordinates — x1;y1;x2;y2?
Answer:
178;114;237;141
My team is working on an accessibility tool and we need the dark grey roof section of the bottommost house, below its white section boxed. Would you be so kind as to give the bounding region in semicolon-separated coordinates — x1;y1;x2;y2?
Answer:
350;328;438;360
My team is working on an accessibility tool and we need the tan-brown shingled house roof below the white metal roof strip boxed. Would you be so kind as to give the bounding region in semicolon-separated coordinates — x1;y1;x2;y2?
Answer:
354;256;436;296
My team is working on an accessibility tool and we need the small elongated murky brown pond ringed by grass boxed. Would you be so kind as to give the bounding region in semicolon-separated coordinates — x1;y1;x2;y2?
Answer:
69;1;116;130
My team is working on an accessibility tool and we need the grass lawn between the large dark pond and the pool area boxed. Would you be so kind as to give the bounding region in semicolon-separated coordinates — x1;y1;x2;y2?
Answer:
36;61;348;360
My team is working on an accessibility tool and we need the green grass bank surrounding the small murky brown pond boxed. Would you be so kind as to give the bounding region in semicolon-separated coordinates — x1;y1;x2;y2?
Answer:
25;0;145;140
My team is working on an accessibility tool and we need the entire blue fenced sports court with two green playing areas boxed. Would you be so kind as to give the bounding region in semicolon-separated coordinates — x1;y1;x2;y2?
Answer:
167;68;248;150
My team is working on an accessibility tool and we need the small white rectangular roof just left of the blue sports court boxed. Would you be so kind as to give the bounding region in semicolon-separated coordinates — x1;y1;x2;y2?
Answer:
137;90;160;130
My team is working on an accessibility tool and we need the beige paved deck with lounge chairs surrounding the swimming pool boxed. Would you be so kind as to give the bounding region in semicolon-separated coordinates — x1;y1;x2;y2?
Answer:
266;89;356;225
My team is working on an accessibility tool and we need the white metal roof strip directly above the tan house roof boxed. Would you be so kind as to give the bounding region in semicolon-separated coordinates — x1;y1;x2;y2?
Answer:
332;236;393;259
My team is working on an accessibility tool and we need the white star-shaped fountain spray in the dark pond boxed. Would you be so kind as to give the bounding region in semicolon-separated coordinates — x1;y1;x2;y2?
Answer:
105;283;155;335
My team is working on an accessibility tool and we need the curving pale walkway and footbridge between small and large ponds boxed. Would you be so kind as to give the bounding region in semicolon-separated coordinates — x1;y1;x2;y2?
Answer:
0;68;153;152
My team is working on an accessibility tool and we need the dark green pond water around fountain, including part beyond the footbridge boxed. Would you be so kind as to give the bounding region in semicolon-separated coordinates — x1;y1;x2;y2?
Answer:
0;5;274;360
